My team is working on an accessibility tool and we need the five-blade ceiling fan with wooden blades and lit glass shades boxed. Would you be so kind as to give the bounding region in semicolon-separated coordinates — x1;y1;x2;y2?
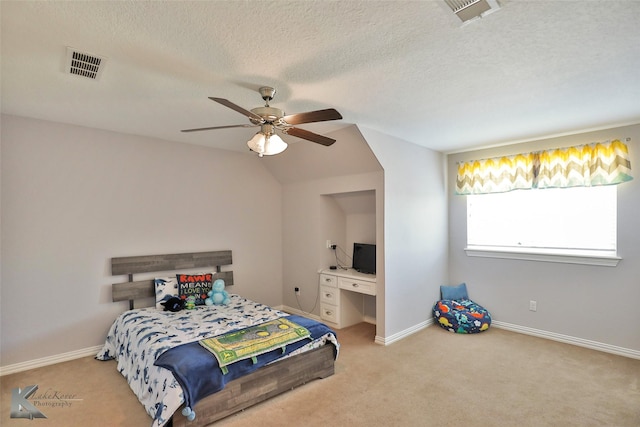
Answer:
182;86;342;157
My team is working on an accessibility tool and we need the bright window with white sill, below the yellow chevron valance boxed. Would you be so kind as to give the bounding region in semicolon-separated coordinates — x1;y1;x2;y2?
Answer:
466;185;619;265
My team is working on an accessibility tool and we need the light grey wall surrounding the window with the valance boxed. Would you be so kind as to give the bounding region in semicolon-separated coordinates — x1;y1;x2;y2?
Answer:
448;125;640;350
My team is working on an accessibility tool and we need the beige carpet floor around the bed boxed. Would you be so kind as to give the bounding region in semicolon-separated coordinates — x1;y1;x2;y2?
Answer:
0;323;640;427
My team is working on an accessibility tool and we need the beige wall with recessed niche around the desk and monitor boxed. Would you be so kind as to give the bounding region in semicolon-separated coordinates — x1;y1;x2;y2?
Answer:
276;125;385;342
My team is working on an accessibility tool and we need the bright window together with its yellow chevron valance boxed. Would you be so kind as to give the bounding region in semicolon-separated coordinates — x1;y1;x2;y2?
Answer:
456;139;633;266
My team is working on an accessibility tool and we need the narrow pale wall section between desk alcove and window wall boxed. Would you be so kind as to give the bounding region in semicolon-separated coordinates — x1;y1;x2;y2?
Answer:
360;128;447;340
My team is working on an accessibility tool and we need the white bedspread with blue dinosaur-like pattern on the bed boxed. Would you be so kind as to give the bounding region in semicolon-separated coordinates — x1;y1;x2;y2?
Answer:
96;294;338;427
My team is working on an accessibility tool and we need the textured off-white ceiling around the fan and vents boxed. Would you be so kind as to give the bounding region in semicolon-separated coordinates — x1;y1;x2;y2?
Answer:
0;0;640;152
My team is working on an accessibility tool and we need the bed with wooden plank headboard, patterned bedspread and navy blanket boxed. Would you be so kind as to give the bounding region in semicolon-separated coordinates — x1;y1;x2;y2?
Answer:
96;251;339;427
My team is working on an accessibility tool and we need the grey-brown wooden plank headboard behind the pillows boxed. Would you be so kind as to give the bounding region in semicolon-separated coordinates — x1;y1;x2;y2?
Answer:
111;250;233;309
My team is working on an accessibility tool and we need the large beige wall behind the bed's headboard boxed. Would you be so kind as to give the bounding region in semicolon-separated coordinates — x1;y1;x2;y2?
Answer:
0;115;282;366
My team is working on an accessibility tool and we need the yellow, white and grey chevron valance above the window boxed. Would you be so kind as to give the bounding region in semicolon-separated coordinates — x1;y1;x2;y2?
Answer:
456;139;632;194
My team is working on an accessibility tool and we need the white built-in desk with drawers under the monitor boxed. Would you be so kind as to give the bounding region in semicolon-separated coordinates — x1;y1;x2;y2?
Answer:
319;269;376;329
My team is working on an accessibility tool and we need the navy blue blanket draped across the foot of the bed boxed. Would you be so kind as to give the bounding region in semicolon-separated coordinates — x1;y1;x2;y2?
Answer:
154;316;337;418
